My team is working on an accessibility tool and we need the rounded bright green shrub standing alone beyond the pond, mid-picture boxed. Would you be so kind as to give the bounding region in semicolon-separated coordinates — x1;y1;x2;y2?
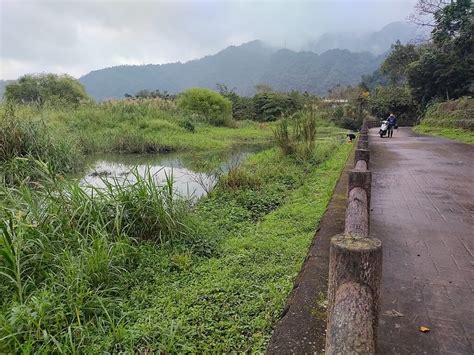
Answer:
178;88;232;126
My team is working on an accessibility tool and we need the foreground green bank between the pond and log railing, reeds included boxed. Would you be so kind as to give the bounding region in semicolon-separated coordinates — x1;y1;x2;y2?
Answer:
0;134;351;353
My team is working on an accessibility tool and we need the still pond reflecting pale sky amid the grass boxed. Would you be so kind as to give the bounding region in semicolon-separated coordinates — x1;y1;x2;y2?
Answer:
81;145;268;198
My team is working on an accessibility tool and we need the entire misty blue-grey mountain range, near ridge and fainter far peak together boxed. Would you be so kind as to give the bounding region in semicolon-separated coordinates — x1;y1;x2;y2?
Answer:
0;22;426;100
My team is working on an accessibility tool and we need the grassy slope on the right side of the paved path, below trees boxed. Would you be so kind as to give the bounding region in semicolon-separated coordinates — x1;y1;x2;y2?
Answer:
414;97;474;144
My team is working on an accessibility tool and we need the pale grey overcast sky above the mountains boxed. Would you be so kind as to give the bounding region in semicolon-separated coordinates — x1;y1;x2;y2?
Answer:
0;0;416;79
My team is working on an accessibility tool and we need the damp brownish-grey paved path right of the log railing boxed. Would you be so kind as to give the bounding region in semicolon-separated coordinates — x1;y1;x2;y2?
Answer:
369;128;474;354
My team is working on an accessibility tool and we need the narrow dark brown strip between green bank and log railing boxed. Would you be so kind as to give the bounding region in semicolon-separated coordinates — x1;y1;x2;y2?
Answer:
267;146;354;354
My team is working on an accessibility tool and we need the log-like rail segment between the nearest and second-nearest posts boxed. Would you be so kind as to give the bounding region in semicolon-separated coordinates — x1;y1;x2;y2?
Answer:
344;187;369;237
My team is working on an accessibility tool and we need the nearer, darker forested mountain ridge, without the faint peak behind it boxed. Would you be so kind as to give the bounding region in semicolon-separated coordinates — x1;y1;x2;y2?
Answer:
80;41;384;100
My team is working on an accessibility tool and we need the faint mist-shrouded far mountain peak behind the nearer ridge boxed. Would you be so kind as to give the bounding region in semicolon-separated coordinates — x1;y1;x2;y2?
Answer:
304;22;429;54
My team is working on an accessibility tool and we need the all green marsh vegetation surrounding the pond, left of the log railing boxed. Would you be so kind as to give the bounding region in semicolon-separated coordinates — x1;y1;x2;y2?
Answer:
0;81;351;353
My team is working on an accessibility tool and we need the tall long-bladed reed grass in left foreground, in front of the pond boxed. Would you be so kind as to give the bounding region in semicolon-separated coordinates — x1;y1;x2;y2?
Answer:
0;161;208;353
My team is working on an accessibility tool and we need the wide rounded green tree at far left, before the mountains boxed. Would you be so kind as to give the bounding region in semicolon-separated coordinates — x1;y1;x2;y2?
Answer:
4;74;90;105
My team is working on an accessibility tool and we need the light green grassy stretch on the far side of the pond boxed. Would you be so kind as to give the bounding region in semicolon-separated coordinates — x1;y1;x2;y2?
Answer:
0;99;272;153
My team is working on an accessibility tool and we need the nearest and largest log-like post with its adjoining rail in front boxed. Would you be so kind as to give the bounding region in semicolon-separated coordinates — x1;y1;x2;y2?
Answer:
326;234;382;354
